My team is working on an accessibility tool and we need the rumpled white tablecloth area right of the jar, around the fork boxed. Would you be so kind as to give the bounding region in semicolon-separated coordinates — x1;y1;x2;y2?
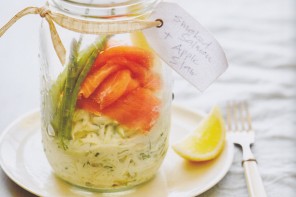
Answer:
171;0;296;197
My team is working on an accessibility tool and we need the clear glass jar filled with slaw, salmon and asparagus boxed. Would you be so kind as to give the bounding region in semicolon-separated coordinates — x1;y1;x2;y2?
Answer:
40;0;172;192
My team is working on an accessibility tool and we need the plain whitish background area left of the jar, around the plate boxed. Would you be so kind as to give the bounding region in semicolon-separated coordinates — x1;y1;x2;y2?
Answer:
0;0;44;197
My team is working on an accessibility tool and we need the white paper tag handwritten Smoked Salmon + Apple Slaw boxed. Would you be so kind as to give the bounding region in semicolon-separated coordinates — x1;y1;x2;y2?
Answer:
143;3;228;91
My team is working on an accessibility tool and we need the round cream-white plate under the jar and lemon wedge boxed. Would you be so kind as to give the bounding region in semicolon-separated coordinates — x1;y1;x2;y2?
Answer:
0;106;233;197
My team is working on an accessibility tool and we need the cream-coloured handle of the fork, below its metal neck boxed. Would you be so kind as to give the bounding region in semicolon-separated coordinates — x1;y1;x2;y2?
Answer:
243;159;266;197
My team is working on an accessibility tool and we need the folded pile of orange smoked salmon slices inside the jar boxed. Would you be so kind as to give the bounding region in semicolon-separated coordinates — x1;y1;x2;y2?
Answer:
77;46;162;132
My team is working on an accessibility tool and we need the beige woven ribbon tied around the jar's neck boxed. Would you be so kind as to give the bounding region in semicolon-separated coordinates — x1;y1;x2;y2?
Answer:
0;7;163;65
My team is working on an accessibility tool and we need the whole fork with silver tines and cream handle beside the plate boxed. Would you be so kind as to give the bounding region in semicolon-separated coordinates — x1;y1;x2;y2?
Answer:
226;101;266;197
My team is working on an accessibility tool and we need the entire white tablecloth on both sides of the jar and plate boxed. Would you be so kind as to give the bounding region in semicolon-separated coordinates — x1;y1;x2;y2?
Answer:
0;0;296;197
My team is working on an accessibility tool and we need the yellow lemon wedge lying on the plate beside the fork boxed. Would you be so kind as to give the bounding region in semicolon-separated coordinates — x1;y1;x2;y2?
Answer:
172;106;225;161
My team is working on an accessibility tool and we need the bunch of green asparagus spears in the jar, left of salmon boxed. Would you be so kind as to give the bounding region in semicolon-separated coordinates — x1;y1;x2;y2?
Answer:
51;37;108;148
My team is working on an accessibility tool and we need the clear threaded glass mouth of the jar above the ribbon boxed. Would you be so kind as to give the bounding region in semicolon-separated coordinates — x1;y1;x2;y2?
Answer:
48;0;160;20
